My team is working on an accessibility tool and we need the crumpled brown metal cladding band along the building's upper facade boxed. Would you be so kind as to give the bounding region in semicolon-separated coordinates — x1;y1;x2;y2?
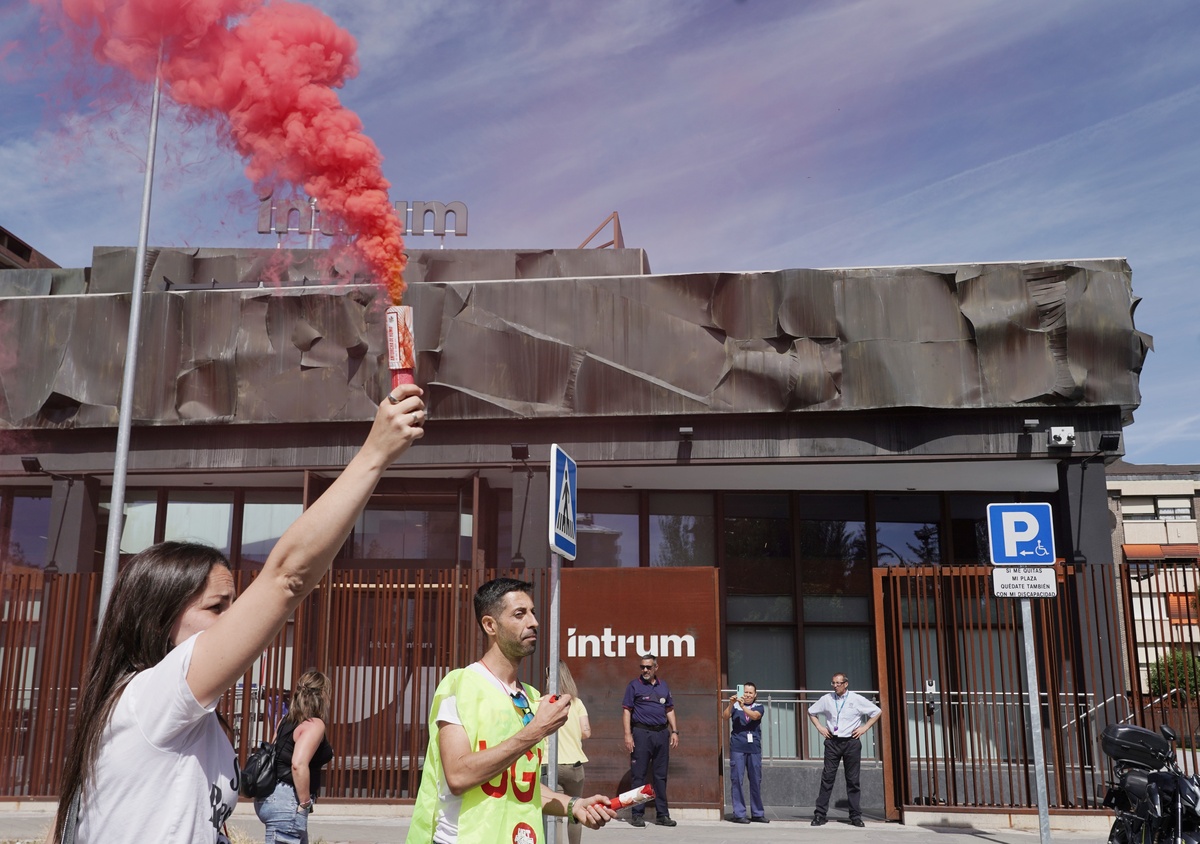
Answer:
0;256;1150;429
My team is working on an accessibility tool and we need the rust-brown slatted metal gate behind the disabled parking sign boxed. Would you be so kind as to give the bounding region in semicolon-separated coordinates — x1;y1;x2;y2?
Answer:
875;564;1136;816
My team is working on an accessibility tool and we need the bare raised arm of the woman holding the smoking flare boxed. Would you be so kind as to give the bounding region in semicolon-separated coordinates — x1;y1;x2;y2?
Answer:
187;384;425;706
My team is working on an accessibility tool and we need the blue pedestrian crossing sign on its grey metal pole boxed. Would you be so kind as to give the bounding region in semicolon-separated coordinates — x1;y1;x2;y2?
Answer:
546;443;578;844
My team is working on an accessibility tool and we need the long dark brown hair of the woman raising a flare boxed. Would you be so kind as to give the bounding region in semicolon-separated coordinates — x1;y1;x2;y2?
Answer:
53;543;230;844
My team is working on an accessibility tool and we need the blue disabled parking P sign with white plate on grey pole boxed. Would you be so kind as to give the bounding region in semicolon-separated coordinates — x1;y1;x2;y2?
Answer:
988;503;1058;844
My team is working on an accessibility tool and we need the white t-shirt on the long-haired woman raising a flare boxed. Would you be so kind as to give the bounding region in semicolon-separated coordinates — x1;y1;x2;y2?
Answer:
77;634;239;844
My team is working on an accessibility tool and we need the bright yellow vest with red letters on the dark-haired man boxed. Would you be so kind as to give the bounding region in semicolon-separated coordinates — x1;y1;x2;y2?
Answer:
406;669;546;844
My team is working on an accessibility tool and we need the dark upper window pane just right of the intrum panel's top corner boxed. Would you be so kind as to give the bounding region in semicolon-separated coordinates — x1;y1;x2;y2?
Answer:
722;493;796;622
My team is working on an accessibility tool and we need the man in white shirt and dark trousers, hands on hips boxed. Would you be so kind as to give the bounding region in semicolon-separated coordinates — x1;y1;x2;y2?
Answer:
809;674;883;826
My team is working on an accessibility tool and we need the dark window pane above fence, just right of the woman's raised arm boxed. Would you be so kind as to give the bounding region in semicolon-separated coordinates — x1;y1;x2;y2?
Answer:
343;505;458;568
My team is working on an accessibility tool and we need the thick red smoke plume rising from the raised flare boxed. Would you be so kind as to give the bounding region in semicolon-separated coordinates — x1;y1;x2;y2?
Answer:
37;0;406;303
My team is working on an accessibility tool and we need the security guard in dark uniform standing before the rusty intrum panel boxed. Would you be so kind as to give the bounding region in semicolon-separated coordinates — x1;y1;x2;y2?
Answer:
620;653;679;826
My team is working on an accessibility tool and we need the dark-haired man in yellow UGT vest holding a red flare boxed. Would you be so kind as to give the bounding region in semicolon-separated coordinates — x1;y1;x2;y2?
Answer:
407;577;617;844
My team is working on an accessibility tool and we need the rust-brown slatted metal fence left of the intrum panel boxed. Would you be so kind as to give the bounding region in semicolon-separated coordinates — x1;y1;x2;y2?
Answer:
0;569;546;800
